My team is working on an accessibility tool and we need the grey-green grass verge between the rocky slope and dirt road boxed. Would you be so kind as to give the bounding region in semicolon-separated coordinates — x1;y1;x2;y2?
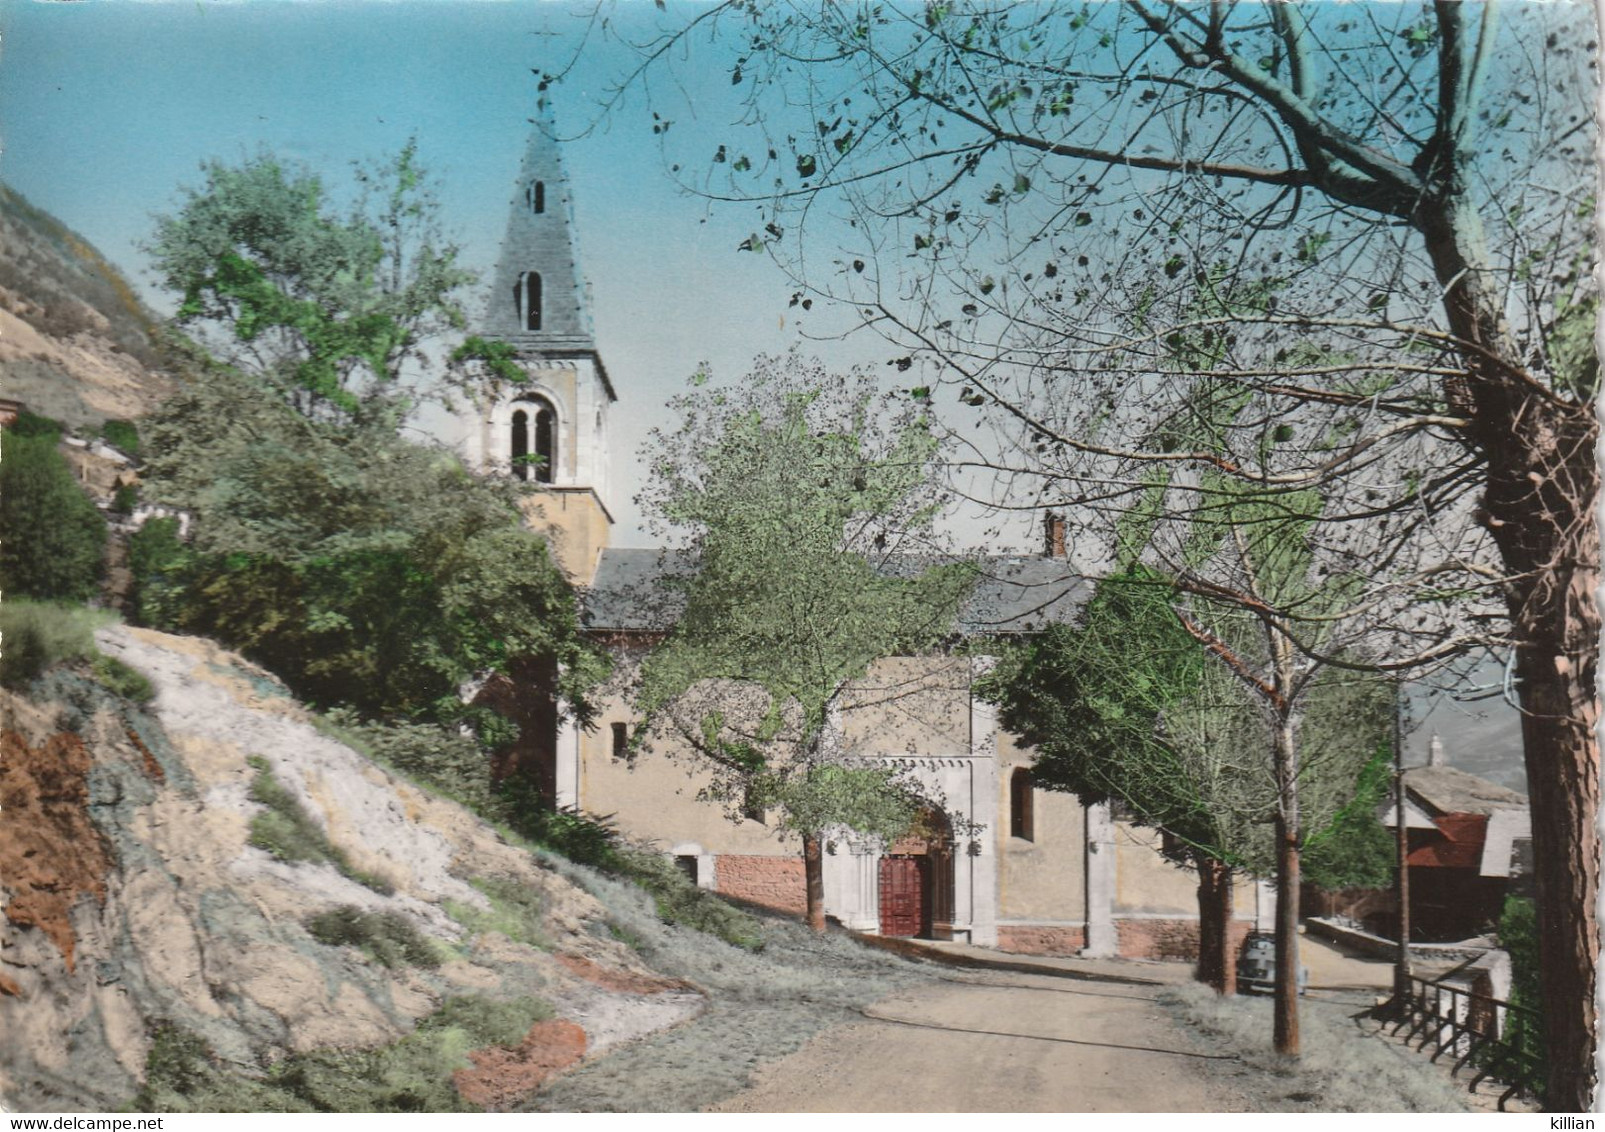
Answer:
530;854;936;1113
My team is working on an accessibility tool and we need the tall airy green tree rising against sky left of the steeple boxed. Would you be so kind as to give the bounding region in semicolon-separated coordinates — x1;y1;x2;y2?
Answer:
149;143;473;419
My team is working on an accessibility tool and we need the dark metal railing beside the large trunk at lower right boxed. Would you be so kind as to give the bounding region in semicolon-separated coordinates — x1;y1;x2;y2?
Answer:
1390;976;1544;1111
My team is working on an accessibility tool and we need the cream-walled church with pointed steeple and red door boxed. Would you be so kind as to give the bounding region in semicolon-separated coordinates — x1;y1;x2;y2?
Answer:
461;114;1274;960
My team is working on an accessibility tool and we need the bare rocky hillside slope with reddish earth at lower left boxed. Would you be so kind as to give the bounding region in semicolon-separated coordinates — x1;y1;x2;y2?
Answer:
0;626;703;1111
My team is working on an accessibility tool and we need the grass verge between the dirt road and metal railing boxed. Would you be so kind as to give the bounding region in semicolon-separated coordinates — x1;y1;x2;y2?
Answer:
1159;983;1470;1113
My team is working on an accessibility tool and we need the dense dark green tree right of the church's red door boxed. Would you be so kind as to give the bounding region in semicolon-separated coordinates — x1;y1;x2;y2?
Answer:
982;565;1382;994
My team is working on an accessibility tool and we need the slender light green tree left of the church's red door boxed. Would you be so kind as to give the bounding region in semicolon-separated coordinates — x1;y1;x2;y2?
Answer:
637;356;973;931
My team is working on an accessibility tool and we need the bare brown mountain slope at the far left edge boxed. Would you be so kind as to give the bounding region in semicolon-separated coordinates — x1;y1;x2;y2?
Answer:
0;185;173;426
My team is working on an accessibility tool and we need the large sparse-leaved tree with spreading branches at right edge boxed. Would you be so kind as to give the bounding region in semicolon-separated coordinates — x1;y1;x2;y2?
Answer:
554;0;1599;1110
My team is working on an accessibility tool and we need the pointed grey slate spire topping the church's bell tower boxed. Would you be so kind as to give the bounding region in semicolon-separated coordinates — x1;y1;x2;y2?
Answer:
483;96;612;359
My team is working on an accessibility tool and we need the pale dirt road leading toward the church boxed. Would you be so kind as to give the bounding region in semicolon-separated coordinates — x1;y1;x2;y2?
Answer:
709;971;1241;1113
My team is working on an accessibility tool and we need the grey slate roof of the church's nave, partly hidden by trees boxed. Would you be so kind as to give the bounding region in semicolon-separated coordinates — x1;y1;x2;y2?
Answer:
583;548;1093;634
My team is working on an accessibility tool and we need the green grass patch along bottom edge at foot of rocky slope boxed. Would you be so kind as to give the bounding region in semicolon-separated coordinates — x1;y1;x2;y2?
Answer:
128;996;552;1113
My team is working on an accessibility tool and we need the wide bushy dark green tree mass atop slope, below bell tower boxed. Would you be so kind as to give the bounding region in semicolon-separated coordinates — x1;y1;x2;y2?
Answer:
132;360;605;719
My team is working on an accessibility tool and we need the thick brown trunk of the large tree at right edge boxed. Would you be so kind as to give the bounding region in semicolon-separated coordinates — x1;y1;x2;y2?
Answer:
1416;197;1600;1111
